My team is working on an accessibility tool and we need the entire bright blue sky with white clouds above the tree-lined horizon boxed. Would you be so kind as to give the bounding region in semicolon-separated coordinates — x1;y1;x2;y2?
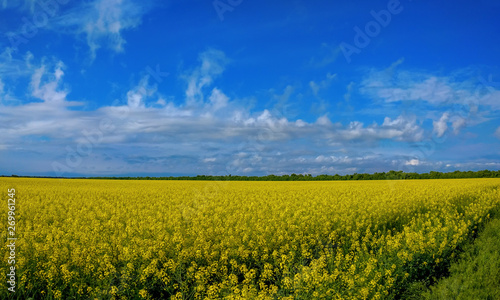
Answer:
0;0;500;176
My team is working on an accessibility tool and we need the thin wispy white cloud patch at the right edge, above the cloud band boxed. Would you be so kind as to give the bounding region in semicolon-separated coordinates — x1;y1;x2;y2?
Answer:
360;61;500;137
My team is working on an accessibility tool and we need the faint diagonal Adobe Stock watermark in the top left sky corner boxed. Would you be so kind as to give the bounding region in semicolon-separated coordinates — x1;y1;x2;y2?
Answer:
7;0;69;51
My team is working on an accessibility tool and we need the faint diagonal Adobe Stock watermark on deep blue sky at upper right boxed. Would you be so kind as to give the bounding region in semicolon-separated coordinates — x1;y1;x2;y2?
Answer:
340;0;411;63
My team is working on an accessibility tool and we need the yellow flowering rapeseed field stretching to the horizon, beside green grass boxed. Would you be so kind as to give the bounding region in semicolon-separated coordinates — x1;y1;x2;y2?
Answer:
0;178;500;299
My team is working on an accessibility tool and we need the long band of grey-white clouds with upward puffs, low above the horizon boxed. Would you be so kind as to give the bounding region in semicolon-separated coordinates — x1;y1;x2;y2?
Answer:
0;49;498;175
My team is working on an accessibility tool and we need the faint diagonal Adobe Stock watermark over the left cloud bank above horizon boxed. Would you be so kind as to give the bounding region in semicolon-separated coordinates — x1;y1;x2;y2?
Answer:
52;65;169;177
